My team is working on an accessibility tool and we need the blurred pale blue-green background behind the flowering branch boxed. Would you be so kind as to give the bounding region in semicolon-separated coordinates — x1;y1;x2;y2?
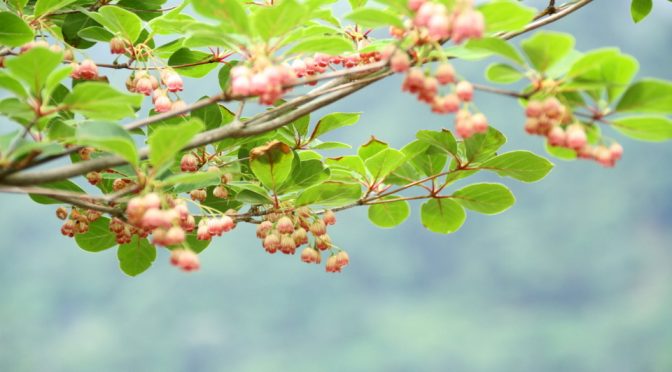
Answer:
0;0;672;372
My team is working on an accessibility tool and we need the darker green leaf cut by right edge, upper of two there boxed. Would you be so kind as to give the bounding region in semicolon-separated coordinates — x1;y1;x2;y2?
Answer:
616;79;672;114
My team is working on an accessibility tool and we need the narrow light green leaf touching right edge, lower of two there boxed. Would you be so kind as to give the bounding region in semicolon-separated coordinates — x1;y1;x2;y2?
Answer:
611;116;672;142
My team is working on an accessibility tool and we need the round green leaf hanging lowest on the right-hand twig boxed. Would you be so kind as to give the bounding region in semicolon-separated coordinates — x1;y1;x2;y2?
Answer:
420;199;467;234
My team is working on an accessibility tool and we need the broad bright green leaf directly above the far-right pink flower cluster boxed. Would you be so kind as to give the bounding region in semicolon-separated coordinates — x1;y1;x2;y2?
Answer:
520;31;574;72
